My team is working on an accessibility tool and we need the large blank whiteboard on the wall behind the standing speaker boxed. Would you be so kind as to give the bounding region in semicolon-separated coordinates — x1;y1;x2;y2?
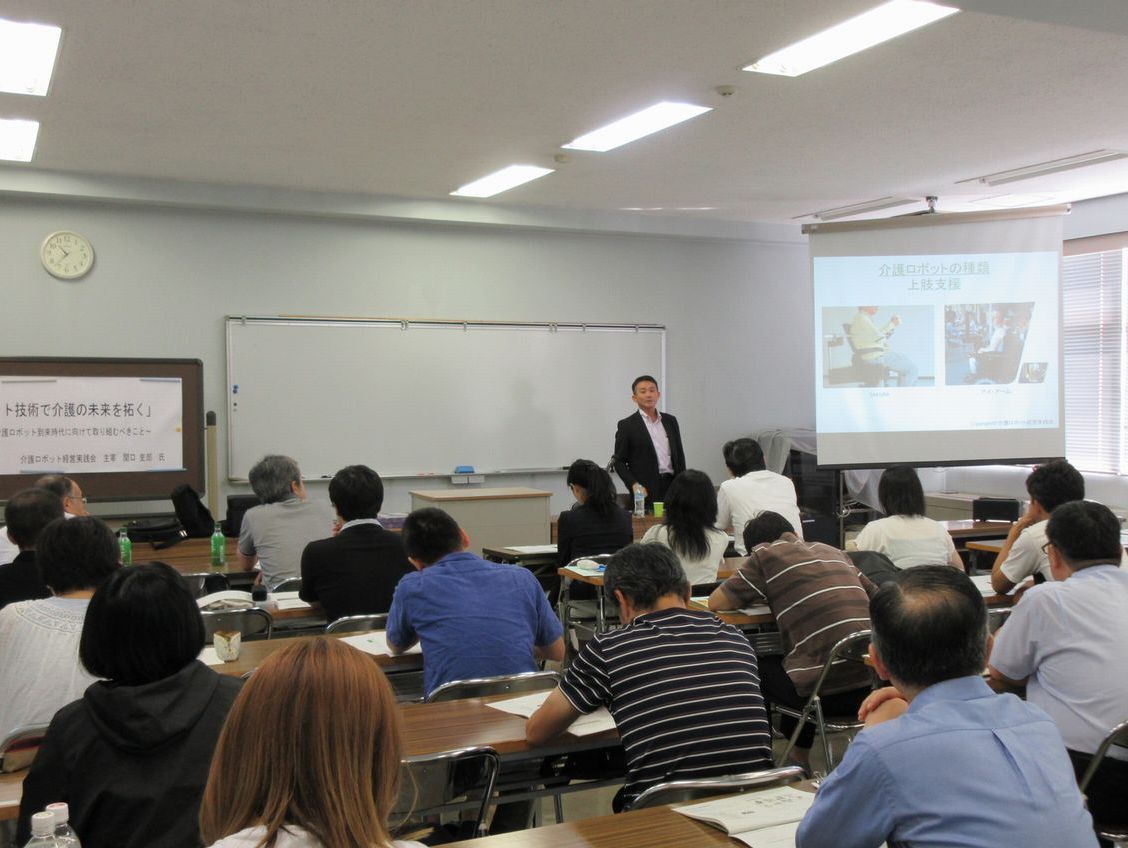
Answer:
227;317;666;479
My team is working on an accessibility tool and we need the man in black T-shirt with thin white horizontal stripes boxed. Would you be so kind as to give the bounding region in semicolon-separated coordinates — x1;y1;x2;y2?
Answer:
526;544;772;812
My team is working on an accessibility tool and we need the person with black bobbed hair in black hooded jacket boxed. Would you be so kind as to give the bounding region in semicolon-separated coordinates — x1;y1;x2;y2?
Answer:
19;563;241;848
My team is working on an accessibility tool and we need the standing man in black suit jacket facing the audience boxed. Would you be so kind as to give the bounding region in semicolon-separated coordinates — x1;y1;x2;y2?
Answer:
615;374;686;504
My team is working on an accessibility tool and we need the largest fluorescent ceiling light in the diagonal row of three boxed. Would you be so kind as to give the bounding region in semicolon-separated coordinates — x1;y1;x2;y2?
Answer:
744;0;959;77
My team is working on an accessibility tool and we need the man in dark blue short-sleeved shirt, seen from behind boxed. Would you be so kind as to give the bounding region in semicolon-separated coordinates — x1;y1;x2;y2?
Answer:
387;507;564;695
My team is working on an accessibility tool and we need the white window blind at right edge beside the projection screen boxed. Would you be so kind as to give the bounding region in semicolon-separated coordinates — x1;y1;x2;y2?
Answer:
1061;249;1128;474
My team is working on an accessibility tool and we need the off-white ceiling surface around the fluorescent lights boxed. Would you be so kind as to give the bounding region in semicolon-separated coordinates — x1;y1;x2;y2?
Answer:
0;0;1128;222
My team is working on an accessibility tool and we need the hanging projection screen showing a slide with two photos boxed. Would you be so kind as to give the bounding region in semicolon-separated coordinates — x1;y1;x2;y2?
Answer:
807;206;1067;468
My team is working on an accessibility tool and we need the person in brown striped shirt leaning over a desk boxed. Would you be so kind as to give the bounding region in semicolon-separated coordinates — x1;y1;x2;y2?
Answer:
708;512;878;767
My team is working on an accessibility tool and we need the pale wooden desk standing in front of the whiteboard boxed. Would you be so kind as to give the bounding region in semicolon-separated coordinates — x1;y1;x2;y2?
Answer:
411;487;552;554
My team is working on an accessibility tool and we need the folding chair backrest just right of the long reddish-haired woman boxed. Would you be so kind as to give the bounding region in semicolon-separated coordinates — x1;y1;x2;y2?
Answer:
391;745;501;837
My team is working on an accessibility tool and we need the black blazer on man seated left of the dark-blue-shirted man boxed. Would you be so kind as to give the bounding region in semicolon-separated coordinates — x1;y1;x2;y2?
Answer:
300;524;413;621
